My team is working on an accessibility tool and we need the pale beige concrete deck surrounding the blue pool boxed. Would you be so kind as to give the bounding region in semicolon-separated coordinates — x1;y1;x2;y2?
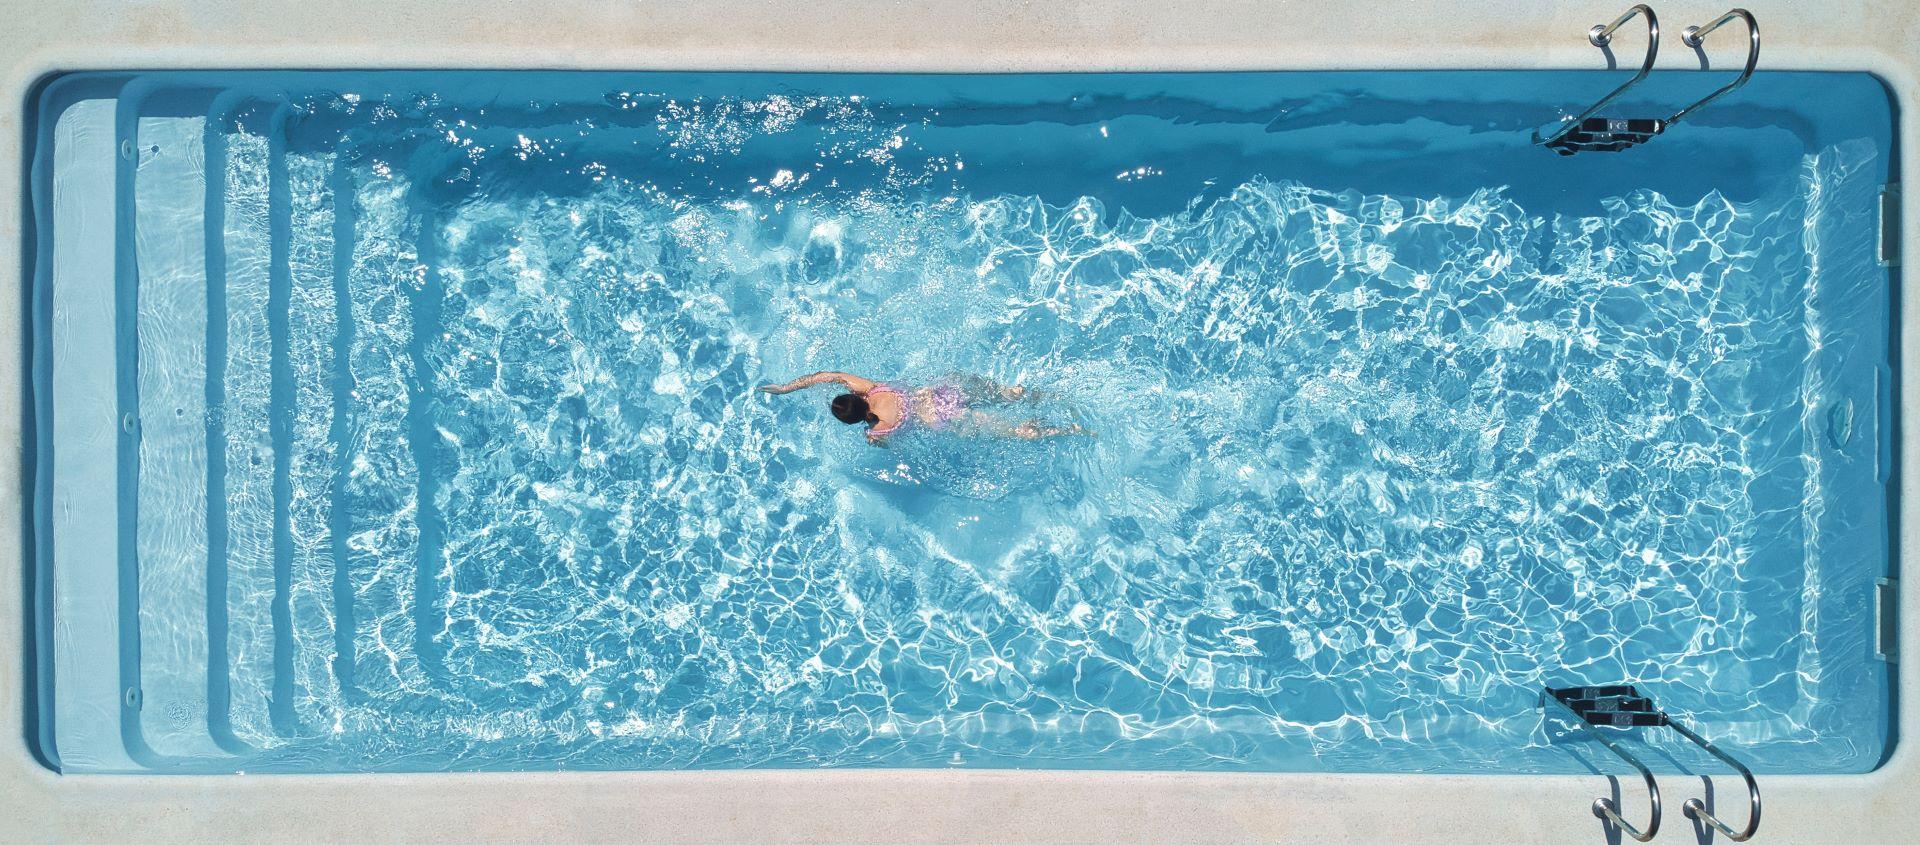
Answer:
0;0;1920;843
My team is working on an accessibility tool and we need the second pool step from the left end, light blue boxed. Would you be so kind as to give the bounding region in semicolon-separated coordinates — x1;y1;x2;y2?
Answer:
115;81;234;766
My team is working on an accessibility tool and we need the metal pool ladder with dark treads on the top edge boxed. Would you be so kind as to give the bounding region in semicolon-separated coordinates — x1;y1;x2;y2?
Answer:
1534;4;1761;156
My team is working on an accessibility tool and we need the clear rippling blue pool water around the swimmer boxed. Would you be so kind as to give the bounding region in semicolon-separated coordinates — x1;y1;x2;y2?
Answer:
26;73;1891;772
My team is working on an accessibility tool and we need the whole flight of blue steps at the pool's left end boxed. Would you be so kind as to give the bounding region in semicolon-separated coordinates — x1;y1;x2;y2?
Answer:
31;75;491;772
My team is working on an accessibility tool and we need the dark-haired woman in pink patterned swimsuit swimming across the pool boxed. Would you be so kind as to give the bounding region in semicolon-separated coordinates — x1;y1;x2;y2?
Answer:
760;373;1091;444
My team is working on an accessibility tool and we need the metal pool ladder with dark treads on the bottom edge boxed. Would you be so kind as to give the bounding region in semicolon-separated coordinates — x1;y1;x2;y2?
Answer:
1542;686;1761;841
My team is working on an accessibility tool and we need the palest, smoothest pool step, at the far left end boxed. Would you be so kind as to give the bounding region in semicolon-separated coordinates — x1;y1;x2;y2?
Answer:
33;79;142;772
